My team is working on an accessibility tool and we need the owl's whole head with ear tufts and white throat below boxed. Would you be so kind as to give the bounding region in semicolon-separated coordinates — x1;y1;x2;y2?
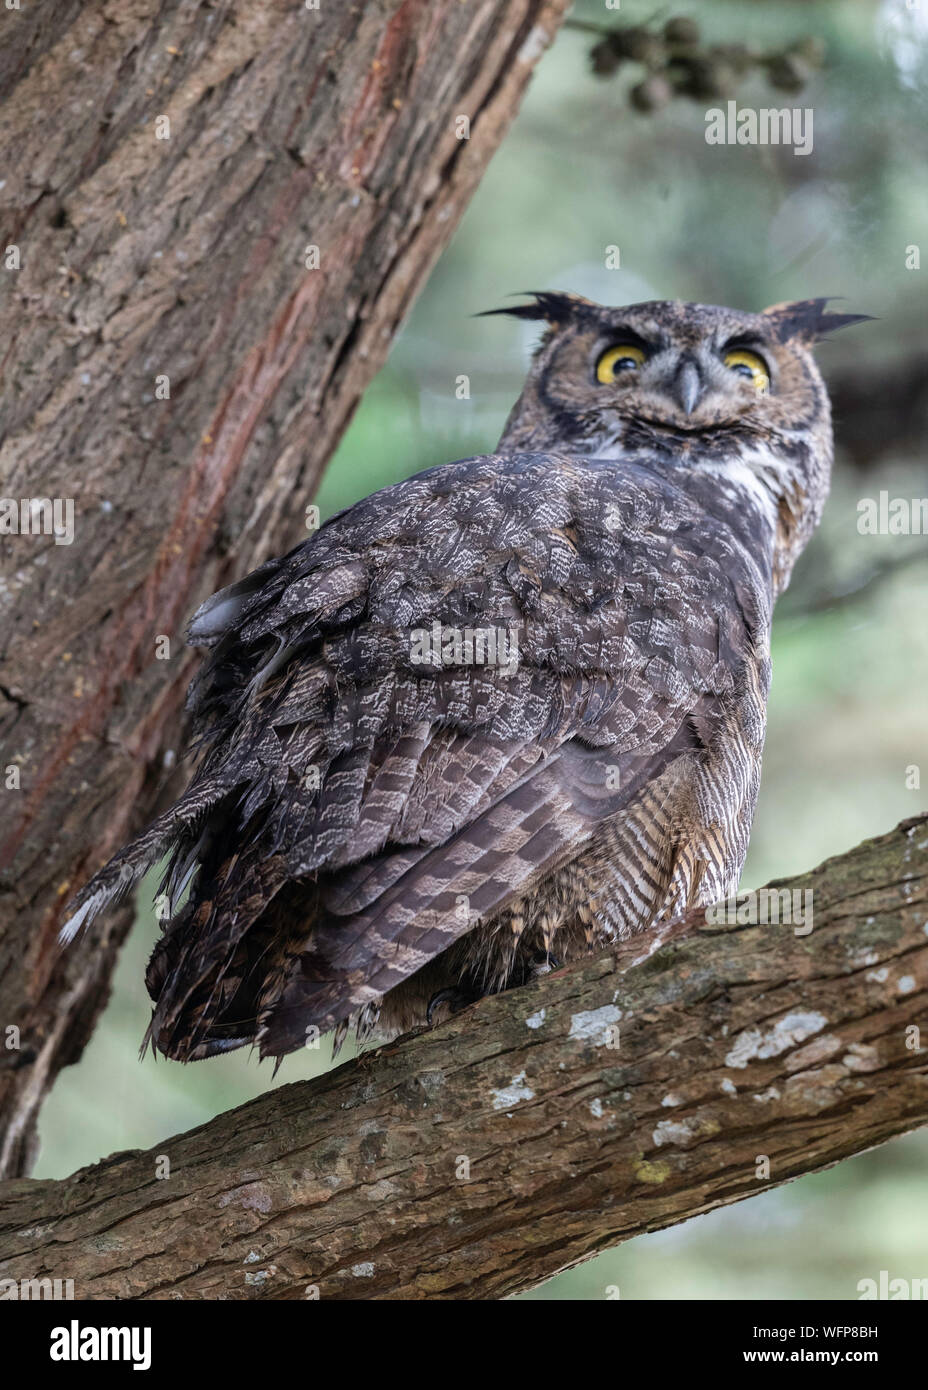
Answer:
492;293;870;592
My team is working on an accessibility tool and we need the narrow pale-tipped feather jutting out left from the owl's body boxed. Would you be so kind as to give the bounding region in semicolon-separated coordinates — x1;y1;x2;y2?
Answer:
58;777;231;945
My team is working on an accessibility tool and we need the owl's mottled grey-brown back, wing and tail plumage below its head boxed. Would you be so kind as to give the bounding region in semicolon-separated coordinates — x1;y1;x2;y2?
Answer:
65;455;774;1059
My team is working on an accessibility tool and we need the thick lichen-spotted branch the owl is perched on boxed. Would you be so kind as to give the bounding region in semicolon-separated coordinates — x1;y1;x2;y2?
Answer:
0;816;928;1300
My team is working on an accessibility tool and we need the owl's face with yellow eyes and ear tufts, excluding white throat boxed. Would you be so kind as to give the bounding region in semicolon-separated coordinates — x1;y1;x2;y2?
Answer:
497;295;860;461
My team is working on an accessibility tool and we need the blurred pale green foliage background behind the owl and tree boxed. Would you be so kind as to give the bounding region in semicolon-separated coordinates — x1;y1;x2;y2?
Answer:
38;0;928;1298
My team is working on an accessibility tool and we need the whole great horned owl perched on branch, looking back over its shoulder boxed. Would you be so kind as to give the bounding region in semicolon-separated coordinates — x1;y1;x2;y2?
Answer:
64;293;860;1061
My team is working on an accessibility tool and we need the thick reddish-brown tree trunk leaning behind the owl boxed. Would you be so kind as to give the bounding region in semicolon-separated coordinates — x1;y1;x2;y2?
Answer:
0;0;567;1175
